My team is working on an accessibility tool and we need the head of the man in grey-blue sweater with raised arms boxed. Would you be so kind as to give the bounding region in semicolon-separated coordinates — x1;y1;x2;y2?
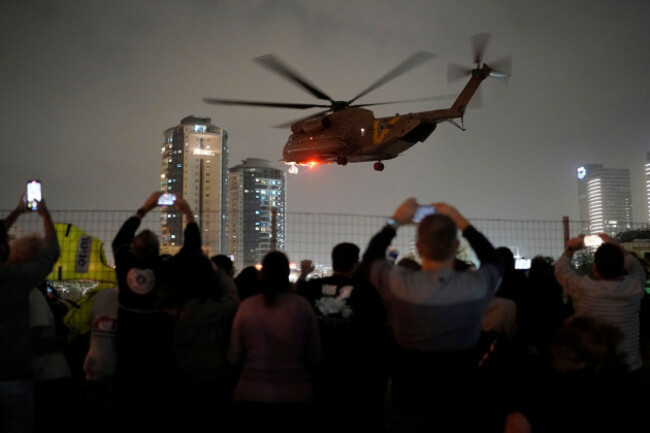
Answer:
417;214;459;261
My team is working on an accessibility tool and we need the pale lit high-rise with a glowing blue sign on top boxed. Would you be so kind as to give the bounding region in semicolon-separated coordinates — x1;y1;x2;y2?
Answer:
578;164;632;235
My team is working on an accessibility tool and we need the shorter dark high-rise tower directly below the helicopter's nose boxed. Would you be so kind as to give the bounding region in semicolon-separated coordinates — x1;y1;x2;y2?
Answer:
227;158;287;270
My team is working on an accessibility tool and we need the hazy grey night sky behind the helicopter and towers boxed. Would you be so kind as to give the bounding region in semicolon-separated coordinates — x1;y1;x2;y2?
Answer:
0;0;650;222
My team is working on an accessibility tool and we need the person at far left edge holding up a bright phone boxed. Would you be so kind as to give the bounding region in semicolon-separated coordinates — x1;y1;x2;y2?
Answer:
0;196;60;432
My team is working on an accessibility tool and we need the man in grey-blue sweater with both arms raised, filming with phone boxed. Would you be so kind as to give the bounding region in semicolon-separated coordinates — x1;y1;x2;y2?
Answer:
363;198;504;431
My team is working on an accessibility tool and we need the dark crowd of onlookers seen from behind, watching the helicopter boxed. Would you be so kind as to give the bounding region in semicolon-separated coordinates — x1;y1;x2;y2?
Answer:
0;192;650;433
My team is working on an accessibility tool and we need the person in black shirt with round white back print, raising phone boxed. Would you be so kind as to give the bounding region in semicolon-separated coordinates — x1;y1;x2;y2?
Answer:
112;191;201;429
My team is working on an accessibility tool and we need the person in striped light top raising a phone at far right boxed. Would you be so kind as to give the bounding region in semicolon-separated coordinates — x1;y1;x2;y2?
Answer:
555;233;645;371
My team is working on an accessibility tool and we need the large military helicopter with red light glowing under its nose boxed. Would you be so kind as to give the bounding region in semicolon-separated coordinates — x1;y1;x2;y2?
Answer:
203;33;511;174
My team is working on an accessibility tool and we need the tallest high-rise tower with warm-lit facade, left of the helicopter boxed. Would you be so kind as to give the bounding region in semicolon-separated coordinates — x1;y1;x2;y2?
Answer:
160;116;228;254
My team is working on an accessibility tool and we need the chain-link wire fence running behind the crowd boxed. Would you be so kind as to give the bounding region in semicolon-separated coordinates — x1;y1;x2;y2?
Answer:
7;210;643;266
